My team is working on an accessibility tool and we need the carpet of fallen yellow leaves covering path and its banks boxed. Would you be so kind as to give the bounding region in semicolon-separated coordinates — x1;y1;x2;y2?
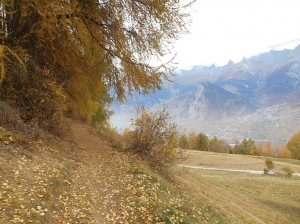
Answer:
0;118;211;224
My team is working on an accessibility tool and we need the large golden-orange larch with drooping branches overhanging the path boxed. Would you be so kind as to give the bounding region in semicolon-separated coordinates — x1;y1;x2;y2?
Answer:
0;0;192;130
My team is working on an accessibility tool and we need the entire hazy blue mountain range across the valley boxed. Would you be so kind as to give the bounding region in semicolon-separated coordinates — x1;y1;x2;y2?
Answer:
112;45;300;142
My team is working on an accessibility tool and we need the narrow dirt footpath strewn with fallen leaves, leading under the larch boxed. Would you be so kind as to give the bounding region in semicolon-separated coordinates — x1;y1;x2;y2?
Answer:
65;122;134;223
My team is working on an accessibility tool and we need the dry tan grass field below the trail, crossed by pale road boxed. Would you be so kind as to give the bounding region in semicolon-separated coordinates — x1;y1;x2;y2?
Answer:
176;152;300;223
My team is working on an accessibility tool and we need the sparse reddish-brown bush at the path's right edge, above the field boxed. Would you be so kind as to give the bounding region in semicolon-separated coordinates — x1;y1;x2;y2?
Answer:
127;107;182;167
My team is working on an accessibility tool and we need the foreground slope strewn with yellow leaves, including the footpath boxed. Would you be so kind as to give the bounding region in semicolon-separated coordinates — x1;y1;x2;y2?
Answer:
0;121;226;223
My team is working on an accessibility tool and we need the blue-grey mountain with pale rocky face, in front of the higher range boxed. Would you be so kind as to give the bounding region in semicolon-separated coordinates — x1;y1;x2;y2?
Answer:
156;82;256;121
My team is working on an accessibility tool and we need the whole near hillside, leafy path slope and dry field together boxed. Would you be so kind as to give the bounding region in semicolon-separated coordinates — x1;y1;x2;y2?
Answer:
0;120;300;224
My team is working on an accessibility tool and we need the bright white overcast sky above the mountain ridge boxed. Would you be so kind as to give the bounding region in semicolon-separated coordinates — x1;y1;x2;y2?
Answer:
172;0;300;69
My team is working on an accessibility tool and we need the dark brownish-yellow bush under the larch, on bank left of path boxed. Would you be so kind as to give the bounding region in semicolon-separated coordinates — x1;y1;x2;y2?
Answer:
0;70;67;133
